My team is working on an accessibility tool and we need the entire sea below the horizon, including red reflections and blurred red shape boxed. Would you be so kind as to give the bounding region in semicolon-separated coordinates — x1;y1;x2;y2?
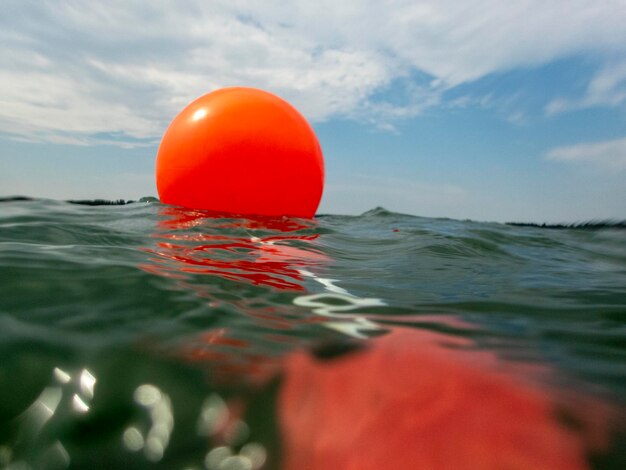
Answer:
0;197;626;470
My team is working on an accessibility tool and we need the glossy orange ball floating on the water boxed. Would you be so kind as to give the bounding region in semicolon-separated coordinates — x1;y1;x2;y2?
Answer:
156;87;324;217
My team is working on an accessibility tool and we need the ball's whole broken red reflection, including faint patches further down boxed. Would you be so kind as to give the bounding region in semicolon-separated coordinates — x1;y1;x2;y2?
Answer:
140;207;328;385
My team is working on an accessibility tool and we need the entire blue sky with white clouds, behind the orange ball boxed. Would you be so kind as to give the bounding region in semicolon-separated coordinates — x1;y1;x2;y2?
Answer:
0;0;626;223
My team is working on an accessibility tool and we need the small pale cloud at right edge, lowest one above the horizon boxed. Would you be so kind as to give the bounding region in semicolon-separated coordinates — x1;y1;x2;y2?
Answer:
546;138;626;172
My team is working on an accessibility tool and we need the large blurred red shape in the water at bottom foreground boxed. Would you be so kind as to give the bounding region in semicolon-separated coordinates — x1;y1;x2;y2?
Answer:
279;328;607;470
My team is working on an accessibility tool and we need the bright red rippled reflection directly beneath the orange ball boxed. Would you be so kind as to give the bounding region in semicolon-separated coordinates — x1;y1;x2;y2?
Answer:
140;207;327;291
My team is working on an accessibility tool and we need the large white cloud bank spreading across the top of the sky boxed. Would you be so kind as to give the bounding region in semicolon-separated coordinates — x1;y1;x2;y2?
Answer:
0;0;626;146
